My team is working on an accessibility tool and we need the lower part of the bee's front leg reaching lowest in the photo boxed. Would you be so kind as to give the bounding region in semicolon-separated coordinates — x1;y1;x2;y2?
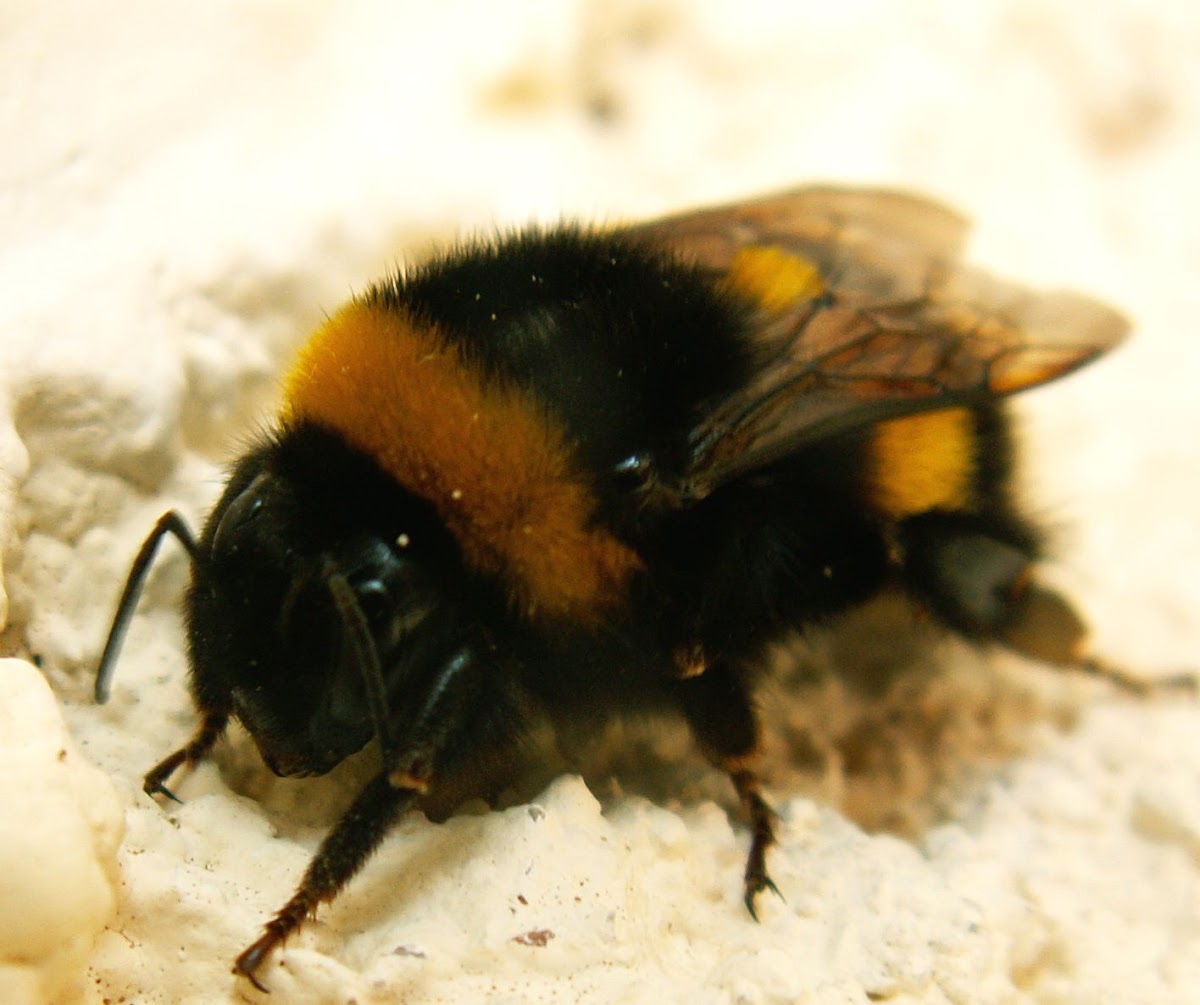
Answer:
233;774;420;992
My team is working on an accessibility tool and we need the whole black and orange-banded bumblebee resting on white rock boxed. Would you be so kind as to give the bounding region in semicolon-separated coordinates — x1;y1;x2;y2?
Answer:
96;187;1127;987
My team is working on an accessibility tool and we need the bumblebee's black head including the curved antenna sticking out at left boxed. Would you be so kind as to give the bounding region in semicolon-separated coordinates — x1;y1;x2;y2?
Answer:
96;422;457;776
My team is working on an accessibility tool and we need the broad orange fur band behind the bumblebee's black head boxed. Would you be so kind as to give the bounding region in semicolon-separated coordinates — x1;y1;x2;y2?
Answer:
283;300;641;621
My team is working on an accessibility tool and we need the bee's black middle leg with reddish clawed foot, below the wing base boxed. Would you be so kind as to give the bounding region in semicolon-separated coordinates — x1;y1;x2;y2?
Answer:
676;663;782;921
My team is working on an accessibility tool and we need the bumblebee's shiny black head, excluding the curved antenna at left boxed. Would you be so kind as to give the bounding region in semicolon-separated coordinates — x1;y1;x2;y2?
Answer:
187;429;443;776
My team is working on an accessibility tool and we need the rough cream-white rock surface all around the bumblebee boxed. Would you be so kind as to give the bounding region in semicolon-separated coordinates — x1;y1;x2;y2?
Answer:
0;0;1200;1005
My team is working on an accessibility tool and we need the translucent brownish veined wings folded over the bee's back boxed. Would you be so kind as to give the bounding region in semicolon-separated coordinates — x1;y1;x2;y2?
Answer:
628;187;1128;504
